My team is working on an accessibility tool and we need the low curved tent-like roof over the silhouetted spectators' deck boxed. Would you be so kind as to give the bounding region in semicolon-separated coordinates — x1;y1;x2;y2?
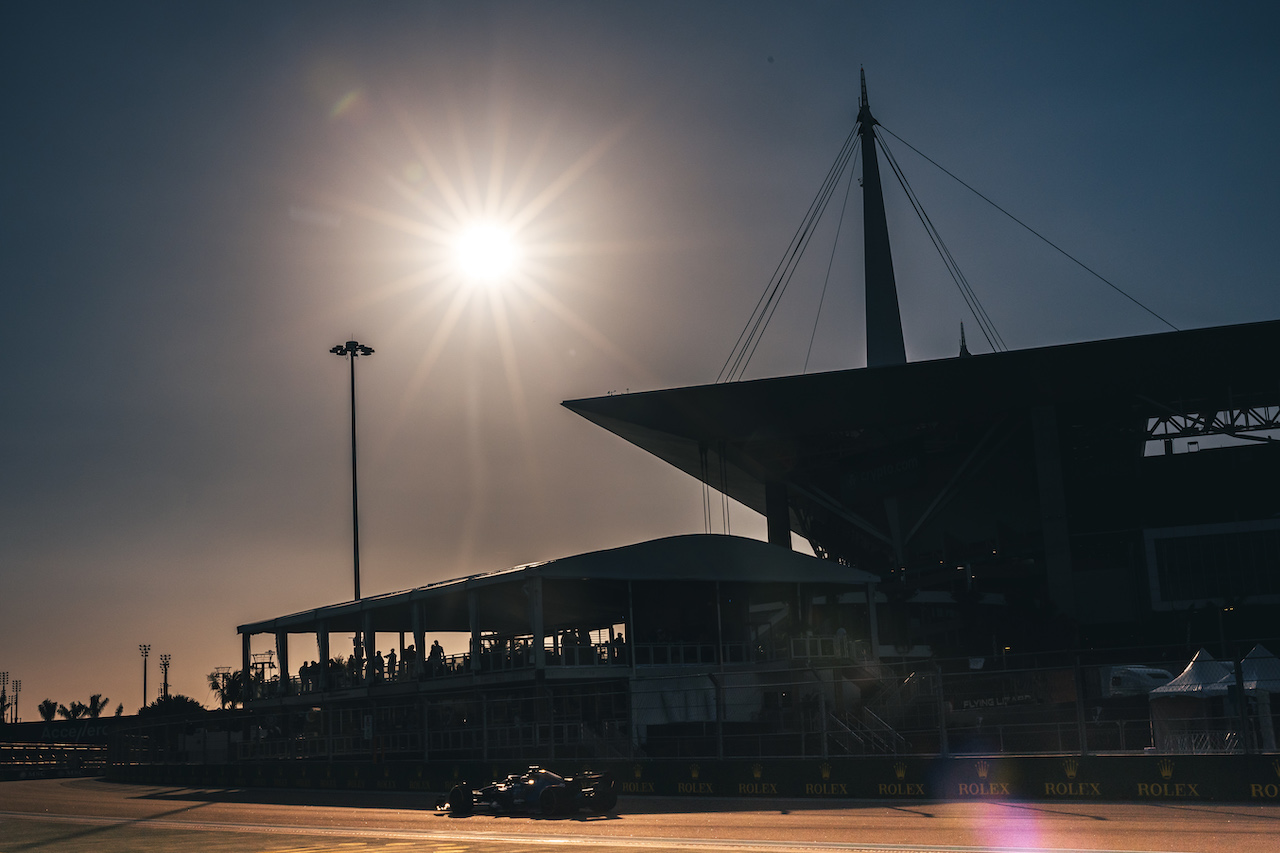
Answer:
237;534;878;634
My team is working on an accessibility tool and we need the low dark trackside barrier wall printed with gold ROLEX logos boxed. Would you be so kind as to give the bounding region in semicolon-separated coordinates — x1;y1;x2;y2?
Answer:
106;754;1280;806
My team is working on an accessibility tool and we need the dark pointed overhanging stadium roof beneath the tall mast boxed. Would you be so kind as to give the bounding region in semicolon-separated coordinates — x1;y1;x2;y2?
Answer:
563;320;1280;512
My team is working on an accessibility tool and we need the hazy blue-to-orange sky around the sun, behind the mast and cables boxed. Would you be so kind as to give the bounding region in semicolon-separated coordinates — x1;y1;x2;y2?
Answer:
0;1;1280;720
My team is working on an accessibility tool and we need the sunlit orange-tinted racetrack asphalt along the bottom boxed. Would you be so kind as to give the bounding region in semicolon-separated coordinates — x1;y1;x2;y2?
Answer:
0;779;1280;853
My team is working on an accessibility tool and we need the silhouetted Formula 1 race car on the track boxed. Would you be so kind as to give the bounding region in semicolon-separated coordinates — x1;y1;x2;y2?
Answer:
435;767;618;816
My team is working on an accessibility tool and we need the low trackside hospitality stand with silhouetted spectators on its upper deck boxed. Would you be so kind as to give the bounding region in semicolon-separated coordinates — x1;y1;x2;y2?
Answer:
238;535;916;758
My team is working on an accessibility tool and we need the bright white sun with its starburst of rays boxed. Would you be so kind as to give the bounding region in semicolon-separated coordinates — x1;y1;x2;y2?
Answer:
303;99;646;416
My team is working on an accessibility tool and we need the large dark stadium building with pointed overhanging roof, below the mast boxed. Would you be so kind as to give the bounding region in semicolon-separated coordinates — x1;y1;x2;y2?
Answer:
564;320;1280;656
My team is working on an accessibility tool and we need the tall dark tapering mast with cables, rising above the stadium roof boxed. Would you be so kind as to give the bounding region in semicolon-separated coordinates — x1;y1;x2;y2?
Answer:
858;70;906;368
